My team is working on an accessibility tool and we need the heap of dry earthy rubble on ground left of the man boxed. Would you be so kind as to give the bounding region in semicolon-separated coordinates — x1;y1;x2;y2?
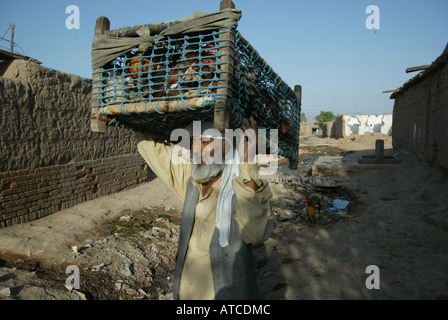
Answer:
59;207;180;300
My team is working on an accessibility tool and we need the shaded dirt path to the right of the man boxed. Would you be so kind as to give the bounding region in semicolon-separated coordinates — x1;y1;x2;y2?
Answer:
260;155;448;299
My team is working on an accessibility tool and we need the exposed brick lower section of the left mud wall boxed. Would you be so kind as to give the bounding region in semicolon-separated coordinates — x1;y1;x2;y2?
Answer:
0;155;147;228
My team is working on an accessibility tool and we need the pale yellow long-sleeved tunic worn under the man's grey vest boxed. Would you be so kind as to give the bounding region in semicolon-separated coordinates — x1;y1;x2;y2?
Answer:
138;138;272;300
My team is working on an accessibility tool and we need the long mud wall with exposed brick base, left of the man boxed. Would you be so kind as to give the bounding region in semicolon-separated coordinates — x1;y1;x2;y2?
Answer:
0;60;149;228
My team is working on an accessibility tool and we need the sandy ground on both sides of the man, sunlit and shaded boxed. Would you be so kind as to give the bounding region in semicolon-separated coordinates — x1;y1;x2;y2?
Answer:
0;134;448;300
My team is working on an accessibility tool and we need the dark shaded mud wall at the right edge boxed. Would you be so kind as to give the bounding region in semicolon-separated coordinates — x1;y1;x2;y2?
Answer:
392;64;448;174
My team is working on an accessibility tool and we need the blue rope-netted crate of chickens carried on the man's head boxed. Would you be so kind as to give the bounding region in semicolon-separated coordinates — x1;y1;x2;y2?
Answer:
92;28;300;160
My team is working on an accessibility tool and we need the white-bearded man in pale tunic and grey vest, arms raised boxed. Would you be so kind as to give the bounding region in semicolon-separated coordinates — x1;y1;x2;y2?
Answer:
138;117;272;300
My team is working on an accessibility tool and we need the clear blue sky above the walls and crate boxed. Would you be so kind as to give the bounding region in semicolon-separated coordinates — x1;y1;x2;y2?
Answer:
0;0;448;121
